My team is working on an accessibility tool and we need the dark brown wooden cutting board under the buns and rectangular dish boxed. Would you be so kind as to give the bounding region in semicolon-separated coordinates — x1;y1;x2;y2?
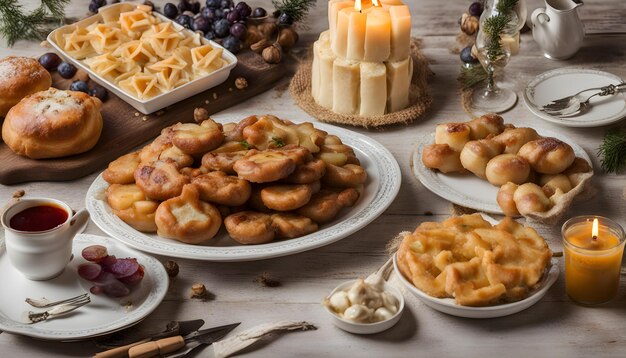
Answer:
0;51;292;185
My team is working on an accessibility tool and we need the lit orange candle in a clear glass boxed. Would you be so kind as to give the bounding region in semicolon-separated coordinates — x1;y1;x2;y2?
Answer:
562;216;624;305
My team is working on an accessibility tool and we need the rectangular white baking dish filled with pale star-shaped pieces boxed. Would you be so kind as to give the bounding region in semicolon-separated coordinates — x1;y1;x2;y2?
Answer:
47;3;237;114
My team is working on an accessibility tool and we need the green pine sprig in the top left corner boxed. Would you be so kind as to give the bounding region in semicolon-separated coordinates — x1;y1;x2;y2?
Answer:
0;0;70;46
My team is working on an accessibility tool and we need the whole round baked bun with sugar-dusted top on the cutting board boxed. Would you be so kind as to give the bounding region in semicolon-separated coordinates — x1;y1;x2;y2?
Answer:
2;88;102;159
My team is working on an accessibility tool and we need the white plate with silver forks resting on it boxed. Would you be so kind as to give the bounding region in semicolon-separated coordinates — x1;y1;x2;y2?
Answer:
524;68;626;127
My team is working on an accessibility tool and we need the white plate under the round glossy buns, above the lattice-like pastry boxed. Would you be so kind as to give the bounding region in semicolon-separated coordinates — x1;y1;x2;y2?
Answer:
411;129;591;214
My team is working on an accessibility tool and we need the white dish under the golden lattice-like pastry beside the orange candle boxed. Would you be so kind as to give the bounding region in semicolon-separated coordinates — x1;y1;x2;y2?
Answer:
393;254;559;318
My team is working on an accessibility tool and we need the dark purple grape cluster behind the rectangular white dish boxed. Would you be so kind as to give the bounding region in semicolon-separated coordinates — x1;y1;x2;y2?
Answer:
163;0;267;53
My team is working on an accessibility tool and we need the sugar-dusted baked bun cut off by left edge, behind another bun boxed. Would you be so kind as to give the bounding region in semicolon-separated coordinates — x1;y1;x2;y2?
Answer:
0;56;52;117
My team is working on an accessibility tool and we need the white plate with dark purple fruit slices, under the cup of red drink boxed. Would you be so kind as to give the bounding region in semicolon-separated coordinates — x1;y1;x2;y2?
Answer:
0;234;169;341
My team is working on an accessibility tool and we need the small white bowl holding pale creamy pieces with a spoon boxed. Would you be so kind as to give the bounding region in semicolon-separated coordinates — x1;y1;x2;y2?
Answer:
324;280;404;334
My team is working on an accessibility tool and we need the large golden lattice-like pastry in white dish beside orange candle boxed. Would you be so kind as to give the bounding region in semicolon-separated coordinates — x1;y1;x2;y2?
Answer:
397;214;552;306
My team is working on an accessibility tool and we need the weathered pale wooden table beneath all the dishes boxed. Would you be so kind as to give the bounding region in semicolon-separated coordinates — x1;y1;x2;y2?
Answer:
0;0;626;357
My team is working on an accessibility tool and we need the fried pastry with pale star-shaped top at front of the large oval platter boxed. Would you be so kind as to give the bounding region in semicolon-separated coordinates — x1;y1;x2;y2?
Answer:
155;184;222;244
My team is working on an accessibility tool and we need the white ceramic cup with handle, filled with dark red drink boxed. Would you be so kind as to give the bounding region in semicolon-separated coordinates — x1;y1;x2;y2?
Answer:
2;198;89;281
